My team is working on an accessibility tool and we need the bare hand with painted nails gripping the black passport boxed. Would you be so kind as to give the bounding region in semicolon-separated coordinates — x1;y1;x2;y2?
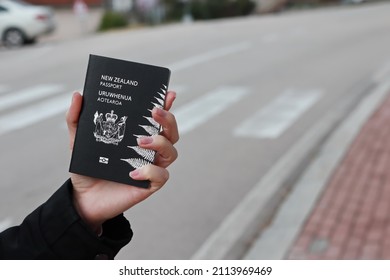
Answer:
66;91;179;232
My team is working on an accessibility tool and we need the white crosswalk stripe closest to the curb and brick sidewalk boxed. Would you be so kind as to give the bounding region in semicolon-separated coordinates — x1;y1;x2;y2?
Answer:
234;89;323;138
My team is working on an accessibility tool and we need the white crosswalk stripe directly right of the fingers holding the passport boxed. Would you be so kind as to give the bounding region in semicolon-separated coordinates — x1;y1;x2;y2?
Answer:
174;87;249;135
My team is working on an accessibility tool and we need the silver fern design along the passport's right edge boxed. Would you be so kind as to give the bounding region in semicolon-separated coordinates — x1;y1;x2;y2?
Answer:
121;85;167;169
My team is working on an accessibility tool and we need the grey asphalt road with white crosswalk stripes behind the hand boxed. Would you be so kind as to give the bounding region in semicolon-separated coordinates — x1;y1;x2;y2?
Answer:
0;3;390;259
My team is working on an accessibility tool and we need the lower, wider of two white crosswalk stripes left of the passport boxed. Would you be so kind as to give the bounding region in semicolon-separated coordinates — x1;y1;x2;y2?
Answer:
0;95;71;135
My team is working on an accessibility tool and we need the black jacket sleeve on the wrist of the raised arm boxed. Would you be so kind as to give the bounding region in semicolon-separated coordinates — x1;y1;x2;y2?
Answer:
0;180;133;260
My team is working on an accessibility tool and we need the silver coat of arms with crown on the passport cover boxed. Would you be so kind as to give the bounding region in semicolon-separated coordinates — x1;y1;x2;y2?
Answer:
93;110;127;145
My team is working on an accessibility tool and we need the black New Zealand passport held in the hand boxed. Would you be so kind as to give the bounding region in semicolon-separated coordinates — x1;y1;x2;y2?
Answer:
69;55;170;188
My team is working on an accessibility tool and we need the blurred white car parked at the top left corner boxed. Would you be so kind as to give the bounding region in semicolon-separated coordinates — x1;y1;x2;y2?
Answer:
0;0;55;47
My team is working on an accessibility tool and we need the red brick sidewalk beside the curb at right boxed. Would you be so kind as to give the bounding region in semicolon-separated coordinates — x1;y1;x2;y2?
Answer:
287;94;390;259
